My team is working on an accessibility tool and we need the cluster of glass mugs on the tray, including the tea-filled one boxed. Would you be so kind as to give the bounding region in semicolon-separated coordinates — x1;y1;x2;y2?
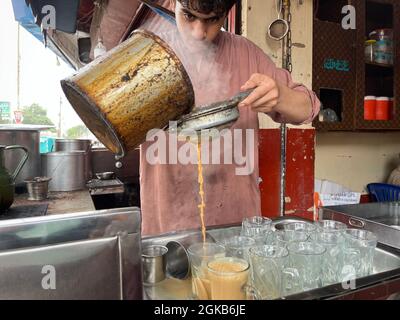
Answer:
189;217;377;300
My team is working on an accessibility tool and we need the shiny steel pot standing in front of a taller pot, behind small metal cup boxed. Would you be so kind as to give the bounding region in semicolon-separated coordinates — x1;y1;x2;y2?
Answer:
42;151;87;191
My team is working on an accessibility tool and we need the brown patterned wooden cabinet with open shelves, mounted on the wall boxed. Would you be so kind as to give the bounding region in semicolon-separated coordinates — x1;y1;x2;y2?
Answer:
313;0;400;131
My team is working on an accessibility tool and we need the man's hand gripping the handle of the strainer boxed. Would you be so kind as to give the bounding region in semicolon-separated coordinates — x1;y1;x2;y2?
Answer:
239;73;281;113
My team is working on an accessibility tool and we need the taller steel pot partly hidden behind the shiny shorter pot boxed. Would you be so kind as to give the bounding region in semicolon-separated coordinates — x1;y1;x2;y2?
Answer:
53;139;93;181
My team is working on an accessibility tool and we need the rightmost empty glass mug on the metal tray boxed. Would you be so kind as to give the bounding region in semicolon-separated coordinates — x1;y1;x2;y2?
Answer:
344;229;378;278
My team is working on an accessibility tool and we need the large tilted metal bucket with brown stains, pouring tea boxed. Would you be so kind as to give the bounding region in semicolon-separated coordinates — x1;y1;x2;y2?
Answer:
61;30;194;157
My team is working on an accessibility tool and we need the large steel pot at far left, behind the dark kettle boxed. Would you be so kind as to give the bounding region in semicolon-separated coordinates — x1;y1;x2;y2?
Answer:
0;125;51;187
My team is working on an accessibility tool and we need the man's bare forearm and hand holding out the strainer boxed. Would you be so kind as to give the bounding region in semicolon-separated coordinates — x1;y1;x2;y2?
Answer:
239;74;319;124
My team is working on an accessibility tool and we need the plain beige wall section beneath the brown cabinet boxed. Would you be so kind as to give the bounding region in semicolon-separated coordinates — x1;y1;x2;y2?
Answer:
316;132;400;192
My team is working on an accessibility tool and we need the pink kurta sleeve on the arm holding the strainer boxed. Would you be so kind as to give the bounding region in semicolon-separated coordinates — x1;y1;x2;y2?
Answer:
256;47;321;125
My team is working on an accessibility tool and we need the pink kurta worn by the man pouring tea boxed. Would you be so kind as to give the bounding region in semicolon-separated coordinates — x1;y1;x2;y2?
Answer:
140;18;320;235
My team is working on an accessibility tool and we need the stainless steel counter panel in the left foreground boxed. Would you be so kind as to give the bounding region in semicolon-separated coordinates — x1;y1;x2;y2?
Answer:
0;208;143;300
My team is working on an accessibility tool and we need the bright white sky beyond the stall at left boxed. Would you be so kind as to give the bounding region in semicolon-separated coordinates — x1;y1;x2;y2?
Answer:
0;0;82;132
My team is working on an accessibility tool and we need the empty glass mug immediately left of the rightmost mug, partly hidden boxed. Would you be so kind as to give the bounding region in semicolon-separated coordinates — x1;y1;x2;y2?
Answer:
311;229;344;286
